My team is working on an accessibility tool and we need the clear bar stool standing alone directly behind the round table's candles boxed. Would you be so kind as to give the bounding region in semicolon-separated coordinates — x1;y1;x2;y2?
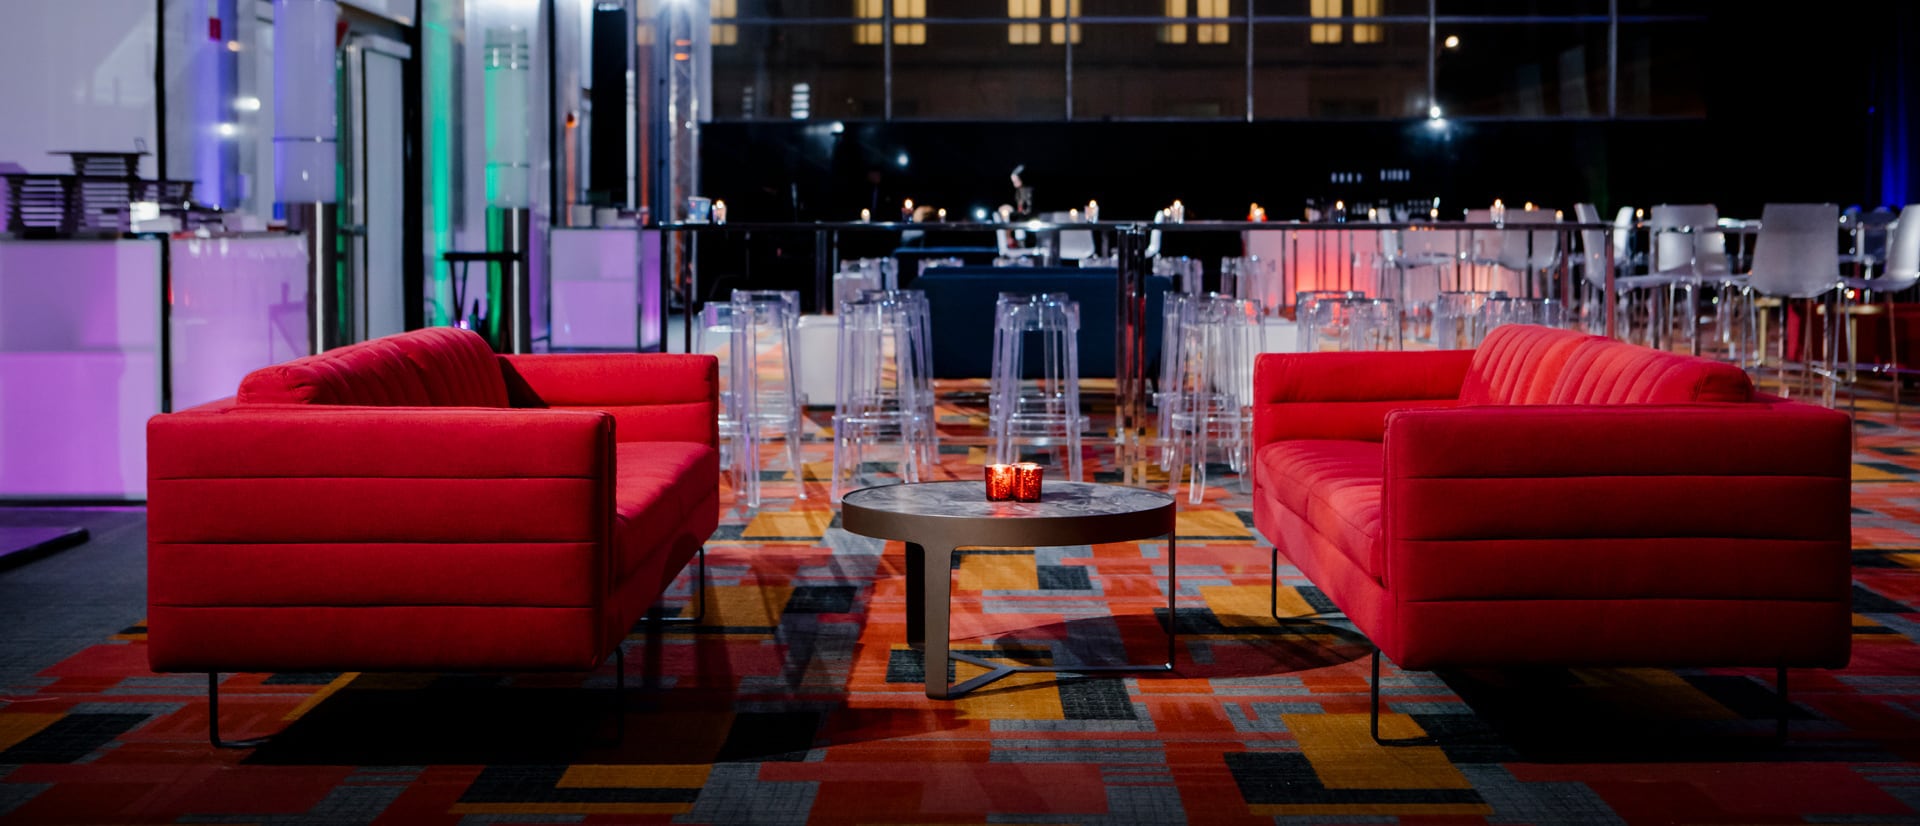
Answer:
987;292;1087;482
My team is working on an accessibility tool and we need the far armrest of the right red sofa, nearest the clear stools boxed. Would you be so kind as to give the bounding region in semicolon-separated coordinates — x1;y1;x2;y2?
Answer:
1254;350;1473;446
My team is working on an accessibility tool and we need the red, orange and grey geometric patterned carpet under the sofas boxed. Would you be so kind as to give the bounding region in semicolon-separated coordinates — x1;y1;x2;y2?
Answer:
11;388;1920;826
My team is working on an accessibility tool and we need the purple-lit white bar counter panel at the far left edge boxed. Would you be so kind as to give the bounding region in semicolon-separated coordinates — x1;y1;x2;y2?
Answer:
0;240;159;499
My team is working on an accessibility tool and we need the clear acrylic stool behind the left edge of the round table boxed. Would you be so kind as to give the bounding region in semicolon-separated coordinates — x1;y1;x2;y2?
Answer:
831;290;937;501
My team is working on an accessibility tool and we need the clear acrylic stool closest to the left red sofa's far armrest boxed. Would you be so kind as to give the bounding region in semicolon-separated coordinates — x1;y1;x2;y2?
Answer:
697;290;806;507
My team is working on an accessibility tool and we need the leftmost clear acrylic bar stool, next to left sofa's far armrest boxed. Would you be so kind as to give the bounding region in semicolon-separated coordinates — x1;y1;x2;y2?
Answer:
730;290;806;505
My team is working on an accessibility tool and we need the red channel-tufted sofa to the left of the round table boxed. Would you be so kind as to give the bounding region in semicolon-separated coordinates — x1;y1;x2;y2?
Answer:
148;328;720;741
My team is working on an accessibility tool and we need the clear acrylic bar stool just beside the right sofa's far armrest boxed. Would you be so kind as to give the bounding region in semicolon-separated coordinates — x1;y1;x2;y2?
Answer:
1160;294;1265;503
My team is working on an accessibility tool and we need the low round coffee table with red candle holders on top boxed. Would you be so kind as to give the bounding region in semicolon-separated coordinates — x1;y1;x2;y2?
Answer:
841;480;1179;699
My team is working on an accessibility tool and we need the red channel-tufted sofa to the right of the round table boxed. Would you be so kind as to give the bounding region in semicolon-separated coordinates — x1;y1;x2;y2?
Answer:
1254;327;1851;737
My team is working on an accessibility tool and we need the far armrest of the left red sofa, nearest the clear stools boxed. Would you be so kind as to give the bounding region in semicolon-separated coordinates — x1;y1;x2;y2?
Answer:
499;353;720;448
